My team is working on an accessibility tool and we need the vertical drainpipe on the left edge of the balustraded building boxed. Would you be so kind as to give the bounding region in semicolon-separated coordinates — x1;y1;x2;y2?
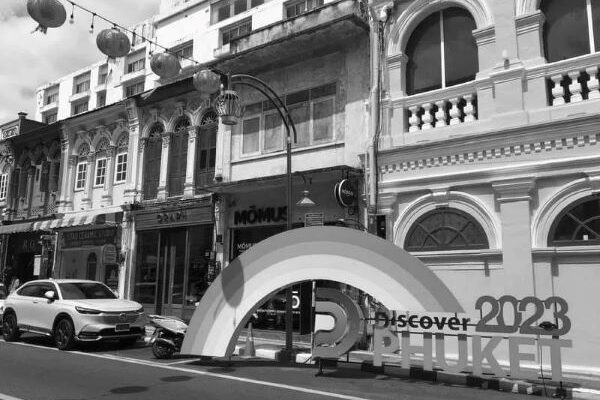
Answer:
366;4;392;214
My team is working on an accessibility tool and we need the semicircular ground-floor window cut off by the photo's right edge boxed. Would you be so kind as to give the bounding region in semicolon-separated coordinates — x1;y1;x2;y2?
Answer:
548;197;600;246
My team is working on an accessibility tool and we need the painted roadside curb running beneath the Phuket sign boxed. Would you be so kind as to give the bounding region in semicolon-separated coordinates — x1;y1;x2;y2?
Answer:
234;343;600;400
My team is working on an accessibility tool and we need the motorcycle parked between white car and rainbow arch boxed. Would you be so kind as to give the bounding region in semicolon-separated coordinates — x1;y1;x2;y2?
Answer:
148;315;188;359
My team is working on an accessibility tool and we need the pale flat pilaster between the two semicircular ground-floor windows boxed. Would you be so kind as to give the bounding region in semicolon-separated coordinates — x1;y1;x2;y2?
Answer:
492;178;535;298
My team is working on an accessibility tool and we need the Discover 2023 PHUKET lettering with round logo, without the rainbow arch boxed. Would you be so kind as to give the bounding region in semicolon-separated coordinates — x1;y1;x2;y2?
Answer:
313;293;572;381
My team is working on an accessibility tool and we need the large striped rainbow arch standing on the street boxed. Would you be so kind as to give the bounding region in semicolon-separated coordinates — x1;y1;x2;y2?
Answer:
181;226;463;357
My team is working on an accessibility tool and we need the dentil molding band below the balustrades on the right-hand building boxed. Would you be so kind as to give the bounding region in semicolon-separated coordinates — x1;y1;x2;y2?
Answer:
379;133;600;175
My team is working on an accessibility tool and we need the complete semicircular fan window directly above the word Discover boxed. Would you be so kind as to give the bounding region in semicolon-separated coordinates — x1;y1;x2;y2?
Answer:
404;208;489;251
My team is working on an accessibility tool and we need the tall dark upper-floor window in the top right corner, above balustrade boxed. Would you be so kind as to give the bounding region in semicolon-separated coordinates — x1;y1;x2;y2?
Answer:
540;0;600;62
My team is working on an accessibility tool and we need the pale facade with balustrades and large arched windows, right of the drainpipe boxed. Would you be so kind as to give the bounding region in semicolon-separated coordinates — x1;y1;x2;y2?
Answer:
376;0;600;374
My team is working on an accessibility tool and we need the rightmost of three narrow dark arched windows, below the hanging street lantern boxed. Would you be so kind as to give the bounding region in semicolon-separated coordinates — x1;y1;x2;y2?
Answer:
195;110;219;186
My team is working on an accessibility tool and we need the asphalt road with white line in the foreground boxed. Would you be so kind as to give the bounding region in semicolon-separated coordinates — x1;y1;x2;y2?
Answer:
0;338;523;400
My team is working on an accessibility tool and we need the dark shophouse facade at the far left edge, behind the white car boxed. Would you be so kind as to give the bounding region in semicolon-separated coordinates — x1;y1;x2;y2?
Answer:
0;113;61;288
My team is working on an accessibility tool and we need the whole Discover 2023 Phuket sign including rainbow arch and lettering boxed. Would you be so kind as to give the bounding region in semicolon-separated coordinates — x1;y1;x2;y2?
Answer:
181;226;571;380
